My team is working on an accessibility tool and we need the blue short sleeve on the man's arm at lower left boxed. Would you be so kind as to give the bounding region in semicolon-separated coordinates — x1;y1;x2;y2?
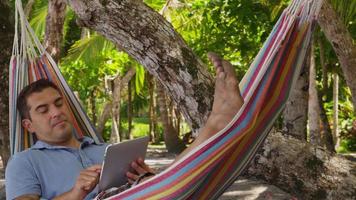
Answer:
5;156;41;200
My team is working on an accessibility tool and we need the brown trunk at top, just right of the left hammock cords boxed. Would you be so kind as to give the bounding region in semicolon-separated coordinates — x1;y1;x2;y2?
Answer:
44;0;67;62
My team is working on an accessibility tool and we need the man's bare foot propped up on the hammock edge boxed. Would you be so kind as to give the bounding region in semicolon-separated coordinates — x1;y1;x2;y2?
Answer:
204;53;243;136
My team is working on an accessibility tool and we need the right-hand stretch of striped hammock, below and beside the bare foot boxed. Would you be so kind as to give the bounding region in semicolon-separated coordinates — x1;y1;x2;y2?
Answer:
101;1;321;199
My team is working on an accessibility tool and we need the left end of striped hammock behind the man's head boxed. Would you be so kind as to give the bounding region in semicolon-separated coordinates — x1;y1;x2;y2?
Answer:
9;0;103;154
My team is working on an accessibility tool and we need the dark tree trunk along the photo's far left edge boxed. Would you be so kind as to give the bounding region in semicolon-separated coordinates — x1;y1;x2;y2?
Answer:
0;0;14;167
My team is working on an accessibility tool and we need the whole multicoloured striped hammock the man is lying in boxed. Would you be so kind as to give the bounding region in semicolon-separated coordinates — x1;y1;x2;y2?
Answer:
10;0;322;199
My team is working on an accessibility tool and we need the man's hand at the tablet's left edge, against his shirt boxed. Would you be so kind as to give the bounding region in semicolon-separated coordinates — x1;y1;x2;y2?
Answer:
69;165;101;199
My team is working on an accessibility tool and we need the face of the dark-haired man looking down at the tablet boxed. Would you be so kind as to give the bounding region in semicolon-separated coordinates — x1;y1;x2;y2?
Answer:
22;87;73;145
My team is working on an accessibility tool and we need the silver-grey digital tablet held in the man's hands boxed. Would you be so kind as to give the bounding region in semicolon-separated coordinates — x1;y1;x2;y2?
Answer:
99;136;149;192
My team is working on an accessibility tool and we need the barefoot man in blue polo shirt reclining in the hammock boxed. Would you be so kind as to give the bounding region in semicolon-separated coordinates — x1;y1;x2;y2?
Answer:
5;54;243;199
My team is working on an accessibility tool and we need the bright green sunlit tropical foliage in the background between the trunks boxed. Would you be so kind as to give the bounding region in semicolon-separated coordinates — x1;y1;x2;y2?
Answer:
30;0;356;151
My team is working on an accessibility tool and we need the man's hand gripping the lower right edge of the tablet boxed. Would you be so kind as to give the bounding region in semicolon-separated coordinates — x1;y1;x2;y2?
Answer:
126;158;154;184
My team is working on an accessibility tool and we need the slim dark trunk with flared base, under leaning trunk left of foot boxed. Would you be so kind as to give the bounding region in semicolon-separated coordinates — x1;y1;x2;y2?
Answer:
157;84;185;154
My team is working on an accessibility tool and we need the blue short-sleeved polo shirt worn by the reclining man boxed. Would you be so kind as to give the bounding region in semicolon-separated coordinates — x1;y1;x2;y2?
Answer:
5;137;107;199
